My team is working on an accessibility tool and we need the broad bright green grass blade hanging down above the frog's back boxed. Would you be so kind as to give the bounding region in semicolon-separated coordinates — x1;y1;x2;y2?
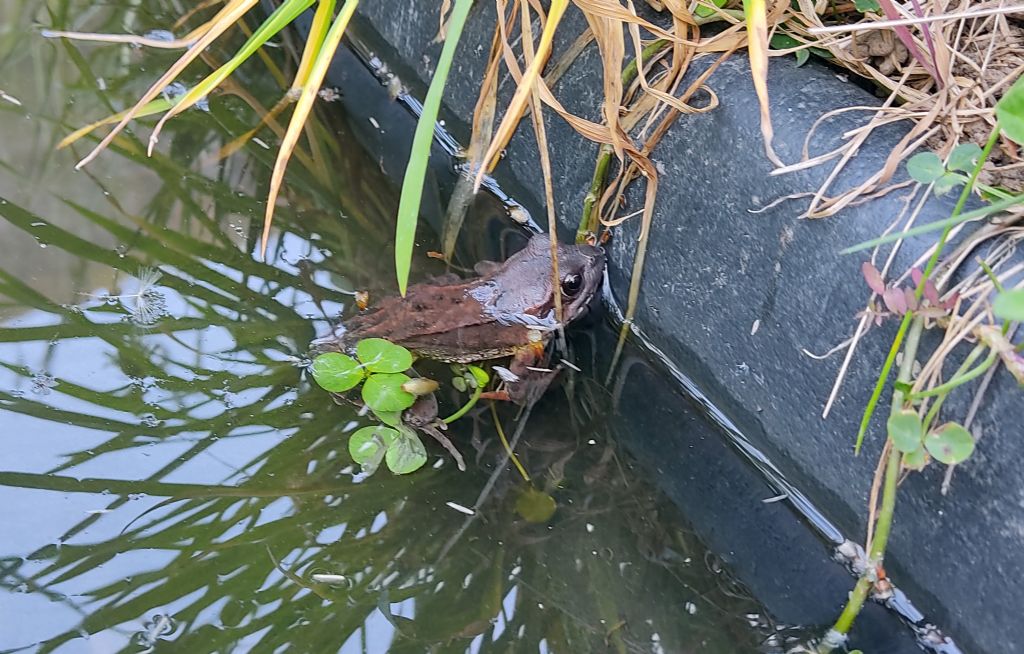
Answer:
394;0;473;295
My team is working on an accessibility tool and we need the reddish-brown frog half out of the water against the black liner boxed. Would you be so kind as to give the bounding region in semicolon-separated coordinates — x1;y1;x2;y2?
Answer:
313;234;604;380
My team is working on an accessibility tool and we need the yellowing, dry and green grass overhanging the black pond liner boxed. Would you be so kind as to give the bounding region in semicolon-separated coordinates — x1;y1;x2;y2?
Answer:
32;0;1024;650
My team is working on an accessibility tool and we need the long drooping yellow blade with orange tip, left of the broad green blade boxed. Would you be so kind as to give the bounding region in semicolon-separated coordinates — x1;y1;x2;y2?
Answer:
260;0;359;258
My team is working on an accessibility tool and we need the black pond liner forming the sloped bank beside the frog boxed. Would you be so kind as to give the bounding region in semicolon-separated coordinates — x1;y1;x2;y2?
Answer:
300;5;1024;653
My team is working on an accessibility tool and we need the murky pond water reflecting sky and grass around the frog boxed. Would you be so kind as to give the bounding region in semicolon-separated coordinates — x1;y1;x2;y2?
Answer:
0;0;794;653
